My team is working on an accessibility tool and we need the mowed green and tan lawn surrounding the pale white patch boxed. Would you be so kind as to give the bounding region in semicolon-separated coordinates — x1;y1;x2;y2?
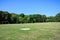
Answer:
0;22;60;40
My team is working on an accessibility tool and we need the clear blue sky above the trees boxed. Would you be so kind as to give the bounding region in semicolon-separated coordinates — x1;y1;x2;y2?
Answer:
0;0;60;16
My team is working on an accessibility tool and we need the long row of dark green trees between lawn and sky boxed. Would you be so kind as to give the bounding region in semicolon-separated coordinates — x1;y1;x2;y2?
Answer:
0;11;60;24
